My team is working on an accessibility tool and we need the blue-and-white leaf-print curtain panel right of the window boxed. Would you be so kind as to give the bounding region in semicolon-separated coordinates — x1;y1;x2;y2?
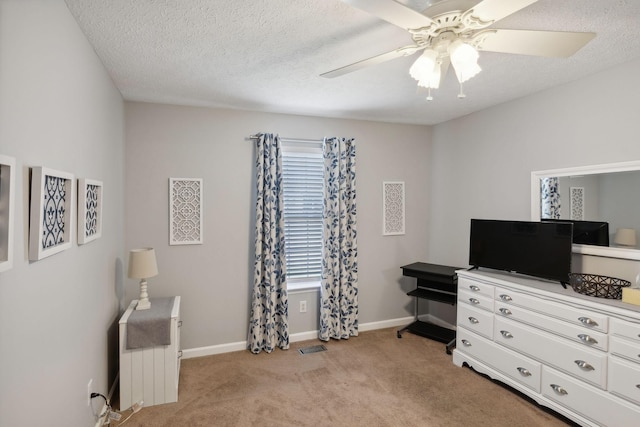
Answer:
318;138;358;341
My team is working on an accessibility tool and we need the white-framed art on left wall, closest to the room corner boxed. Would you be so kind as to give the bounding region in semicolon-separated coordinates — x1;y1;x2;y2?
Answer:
78;178;102;245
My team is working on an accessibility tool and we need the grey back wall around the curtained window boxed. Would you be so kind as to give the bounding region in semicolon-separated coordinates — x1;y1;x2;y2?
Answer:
125;103;431;349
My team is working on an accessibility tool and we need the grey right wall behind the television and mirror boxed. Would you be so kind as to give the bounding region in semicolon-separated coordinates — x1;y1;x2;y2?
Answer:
429;60;640;281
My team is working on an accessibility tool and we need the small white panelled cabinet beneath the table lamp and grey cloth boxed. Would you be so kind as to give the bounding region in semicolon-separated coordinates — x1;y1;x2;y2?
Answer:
119;296;182;410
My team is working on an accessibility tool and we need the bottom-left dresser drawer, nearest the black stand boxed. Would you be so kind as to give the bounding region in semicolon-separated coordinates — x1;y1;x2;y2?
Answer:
456;328;542;393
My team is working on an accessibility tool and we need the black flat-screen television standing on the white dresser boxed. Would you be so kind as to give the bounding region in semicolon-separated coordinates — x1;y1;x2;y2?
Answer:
469;219;573;284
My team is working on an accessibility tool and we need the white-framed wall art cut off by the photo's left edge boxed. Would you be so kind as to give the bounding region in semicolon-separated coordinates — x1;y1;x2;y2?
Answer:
0;155;16;271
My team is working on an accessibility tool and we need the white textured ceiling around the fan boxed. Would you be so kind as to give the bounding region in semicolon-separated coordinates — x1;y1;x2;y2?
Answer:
65;0;640;125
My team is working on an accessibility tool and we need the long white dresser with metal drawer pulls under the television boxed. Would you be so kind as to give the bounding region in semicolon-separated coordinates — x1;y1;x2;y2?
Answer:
453;271;640;427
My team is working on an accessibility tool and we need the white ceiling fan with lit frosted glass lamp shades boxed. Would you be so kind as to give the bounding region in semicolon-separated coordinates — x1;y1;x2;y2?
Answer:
321;0;595;100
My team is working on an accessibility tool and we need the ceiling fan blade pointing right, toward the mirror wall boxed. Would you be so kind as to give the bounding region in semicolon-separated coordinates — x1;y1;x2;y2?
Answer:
474;30;596;58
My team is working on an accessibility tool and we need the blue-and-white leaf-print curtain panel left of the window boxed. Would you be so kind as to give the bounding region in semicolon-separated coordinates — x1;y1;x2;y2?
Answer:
248;134;289;353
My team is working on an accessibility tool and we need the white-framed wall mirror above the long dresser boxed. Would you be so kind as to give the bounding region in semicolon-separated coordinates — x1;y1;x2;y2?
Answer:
531;161;640;260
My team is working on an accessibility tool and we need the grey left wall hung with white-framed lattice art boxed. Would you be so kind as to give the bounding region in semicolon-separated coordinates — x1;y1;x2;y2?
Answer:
0;0;124;426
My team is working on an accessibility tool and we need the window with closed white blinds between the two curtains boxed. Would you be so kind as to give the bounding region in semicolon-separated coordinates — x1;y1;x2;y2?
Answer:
282;141;324;285
